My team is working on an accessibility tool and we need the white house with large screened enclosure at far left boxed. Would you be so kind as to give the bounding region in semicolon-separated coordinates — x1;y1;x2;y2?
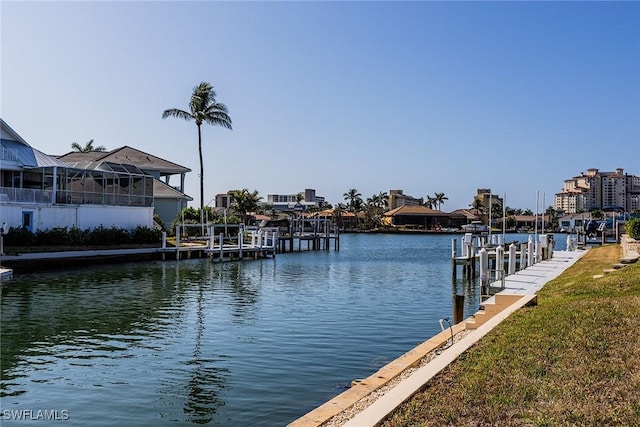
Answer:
0;119;153;231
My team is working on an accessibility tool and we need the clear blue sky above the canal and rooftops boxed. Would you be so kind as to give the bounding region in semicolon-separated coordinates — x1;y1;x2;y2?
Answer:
0;1;640;211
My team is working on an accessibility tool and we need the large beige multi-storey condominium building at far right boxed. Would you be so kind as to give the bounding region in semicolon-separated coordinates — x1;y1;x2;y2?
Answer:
554;168;640;214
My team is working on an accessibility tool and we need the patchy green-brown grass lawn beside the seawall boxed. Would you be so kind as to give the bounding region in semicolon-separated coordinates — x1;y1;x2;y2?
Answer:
382;245;640;426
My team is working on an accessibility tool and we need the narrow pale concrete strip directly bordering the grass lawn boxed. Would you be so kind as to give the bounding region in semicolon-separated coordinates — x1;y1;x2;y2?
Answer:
344;294;537;427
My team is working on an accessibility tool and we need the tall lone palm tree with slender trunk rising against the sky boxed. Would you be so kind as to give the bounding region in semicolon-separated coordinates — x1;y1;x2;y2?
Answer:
162;82;232;227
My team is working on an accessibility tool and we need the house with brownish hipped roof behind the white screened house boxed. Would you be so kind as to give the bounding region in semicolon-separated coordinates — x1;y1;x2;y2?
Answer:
57;145;193;226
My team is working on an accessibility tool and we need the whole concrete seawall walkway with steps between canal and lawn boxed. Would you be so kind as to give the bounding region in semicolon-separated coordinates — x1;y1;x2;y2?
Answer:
289;250;585;427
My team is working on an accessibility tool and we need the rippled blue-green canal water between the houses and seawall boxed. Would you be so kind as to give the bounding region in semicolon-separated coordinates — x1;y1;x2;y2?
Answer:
0;234;560;426
